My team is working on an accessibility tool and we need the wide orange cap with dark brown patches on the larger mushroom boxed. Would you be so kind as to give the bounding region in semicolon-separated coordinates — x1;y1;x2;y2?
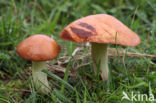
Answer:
60;14;140;46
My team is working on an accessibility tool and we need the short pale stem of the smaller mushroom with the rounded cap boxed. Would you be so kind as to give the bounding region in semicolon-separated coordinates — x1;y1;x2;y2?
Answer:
32;61;49;93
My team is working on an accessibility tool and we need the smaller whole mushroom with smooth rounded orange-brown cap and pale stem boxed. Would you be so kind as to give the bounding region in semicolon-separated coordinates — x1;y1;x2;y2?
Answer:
16;34;60;93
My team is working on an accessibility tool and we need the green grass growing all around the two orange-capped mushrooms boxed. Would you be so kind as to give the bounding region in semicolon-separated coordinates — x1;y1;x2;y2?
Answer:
0;0;156;103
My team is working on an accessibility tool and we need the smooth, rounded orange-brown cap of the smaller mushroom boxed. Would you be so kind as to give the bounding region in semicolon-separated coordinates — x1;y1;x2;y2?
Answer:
16;34;60;61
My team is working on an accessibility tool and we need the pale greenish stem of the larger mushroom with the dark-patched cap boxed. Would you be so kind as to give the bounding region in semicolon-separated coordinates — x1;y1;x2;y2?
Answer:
91;43;109;81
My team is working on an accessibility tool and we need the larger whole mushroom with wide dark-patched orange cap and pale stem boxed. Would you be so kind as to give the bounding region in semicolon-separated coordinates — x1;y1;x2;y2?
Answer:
60;14;140;81
